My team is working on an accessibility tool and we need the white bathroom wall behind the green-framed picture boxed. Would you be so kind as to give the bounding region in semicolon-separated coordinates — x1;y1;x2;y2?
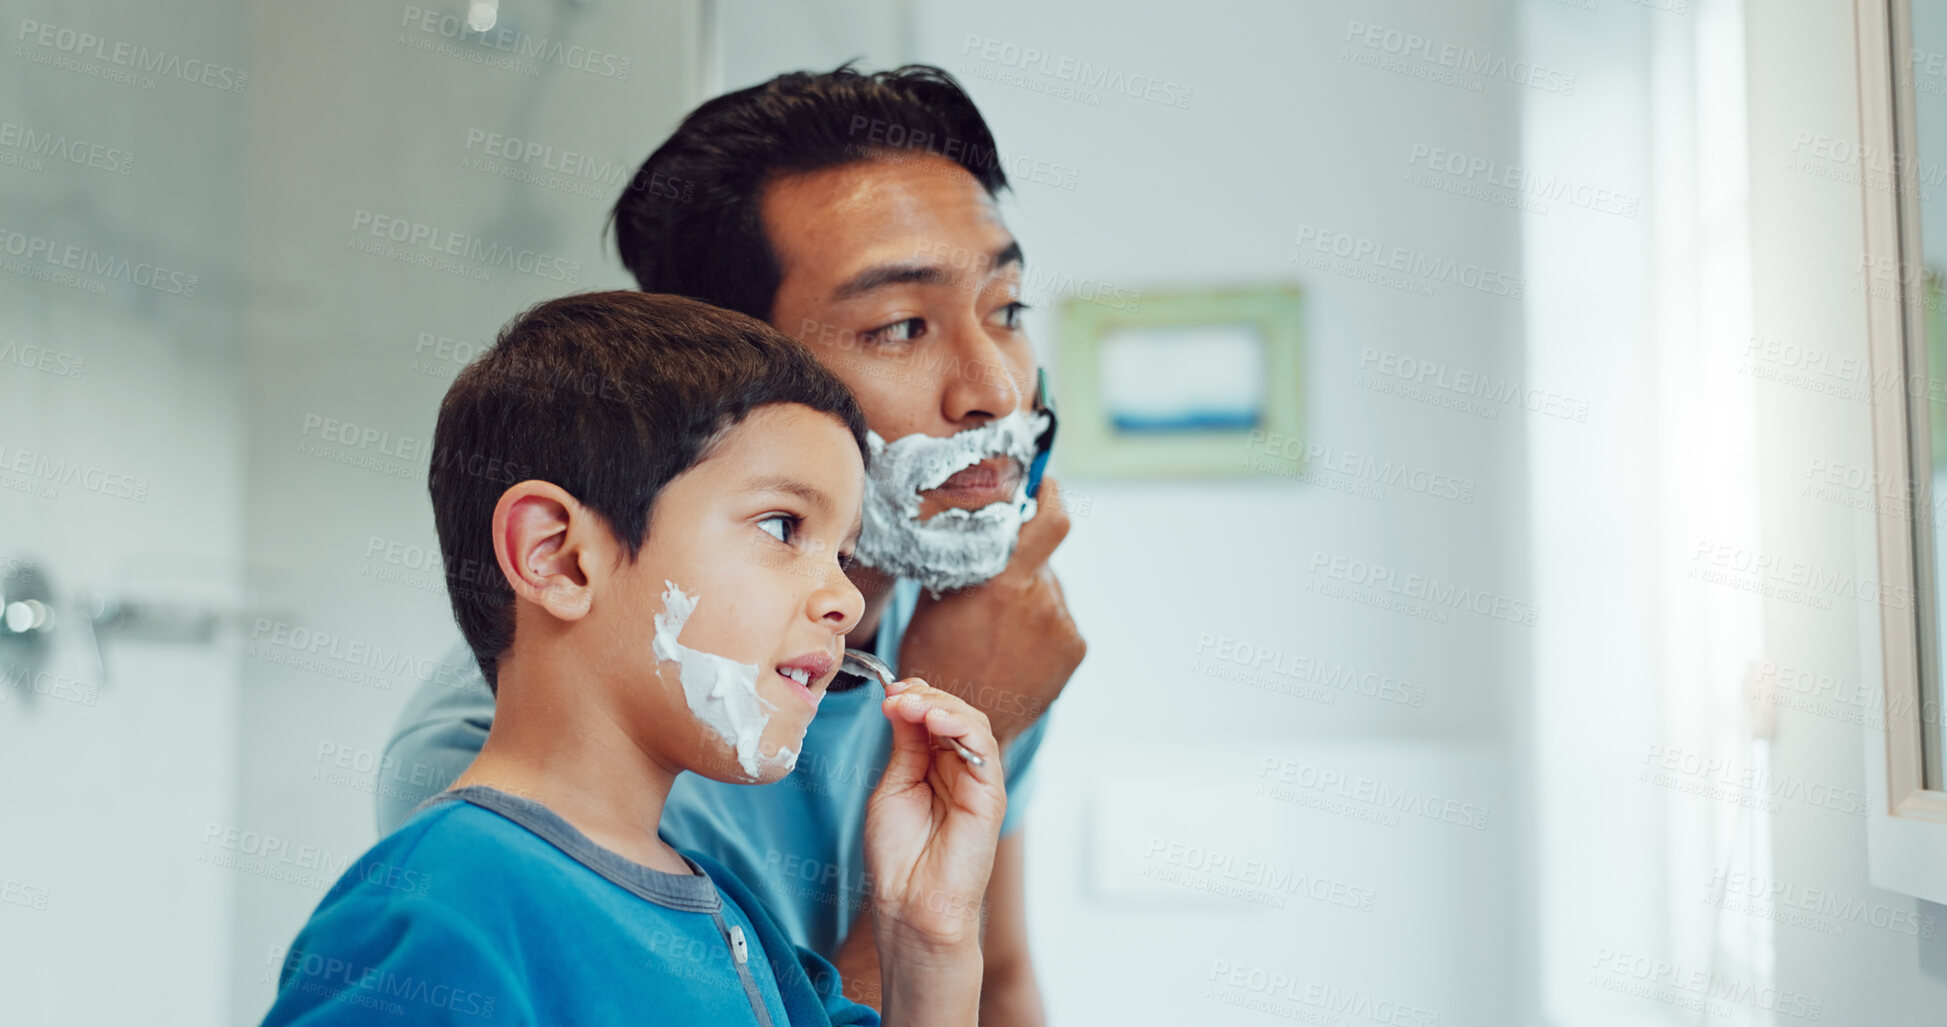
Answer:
915;2;1552;1023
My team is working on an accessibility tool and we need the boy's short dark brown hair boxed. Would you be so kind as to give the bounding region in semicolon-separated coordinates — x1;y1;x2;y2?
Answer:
441;290;866;690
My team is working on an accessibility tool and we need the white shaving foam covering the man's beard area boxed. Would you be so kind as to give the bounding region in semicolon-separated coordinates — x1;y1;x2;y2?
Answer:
857;409;1047;592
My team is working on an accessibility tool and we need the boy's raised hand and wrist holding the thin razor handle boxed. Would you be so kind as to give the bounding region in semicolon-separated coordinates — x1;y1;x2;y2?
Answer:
864;678;1007;966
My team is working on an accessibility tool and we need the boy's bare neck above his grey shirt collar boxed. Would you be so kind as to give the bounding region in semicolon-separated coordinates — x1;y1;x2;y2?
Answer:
452;651;689;873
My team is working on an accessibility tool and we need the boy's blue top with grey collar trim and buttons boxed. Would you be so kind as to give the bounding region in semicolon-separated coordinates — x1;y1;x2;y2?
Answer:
265;785;878;1027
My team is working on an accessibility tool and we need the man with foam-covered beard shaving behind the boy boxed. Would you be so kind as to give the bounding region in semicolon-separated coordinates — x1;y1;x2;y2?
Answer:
380;66;1086;1025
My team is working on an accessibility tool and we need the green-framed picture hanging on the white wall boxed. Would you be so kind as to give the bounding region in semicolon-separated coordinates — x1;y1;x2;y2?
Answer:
1057;285;1304;477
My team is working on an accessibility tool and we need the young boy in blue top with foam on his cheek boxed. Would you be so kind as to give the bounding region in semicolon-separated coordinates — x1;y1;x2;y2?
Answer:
265;292;1007;1027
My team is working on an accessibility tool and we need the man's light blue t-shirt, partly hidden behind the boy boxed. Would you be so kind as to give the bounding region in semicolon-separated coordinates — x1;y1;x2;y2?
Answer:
376;581;1047;959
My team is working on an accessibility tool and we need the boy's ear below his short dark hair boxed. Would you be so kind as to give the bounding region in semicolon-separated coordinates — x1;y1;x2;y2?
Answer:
493;481;609;620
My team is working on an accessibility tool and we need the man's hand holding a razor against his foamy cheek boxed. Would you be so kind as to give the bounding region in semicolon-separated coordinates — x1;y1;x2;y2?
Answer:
900;477;1088;744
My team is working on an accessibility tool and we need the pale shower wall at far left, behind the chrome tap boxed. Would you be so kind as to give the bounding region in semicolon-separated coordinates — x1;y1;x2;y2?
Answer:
0;0;249;1025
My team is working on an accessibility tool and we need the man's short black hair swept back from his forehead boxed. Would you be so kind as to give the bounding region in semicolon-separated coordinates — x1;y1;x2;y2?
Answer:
613;62;1007;320
